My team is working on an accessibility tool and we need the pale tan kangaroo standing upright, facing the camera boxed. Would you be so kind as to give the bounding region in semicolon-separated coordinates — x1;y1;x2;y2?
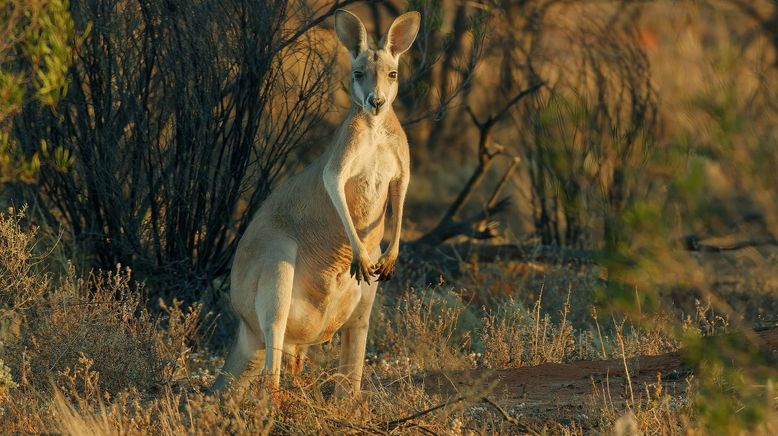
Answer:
213;9;421;395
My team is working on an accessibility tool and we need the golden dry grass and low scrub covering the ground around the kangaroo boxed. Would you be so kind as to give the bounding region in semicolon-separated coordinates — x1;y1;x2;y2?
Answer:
0;205;776;435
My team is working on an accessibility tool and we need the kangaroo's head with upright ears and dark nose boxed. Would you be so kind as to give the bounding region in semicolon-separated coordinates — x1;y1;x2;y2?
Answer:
335;9;421;116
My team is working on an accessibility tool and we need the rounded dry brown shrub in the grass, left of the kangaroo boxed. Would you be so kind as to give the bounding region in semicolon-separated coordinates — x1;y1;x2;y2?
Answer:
26;267;167;393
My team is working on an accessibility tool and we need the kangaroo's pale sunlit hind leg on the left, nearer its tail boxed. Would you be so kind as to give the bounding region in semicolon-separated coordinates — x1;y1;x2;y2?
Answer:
254;235;297;387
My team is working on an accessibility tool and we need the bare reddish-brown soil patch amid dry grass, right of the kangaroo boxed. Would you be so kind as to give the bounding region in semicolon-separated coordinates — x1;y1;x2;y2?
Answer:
416;328;778;417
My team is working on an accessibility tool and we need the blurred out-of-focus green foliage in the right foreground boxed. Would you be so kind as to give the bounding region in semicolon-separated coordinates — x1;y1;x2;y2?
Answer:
598;42;778;434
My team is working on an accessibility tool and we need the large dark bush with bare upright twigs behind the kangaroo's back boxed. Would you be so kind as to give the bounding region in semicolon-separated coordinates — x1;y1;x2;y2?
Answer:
10;0;334;301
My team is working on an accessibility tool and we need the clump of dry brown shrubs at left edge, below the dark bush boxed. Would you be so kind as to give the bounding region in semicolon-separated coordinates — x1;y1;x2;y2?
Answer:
0;205;201;402
